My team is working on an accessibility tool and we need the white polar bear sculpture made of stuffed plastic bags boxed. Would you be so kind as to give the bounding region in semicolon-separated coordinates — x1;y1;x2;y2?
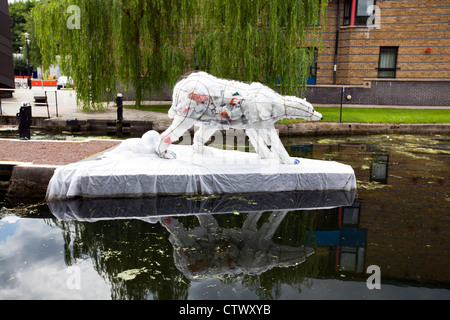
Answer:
157;72;322;164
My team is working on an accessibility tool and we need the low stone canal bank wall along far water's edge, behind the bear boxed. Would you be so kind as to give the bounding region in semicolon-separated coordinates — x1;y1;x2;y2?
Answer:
0;114;450;137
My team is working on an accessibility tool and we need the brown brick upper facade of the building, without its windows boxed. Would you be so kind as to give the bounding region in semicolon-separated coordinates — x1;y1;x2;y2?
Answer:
317;0;450;85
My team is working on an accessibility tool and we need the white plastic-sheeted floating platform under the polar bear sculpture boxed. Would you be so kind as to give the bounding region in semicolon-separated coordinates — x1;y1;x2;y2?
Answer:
47;131;356;200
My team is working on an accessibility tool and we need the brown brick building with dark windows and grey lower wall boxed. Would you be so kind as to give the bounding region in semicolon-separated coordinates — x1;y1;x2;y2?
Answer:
306;0;450;106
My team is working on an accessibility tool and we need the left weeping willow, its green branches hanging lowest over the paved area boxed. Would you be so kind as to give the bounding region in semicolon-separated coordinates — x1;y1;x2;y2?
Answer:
32;0;195;111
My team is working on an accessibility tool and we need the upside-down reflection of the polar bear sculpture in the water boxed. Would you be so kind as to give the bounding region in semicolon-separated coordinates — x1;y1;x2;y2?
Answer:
161;211;314;279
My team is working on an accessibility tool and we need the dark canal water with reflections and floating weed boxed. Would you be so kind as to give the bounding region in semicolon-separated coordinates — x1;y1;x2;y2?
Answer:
0;135;450;300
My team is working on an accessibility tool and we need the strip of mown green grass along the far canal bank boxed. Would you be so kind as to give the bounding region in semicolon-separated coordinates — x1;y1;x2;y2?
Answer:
124;105;450;123
